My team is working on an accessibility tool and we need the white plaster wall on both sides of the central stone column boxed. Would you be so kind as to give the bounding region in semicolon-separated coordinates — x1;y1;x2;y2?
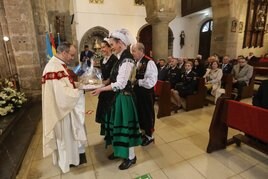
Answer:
73;0;211;58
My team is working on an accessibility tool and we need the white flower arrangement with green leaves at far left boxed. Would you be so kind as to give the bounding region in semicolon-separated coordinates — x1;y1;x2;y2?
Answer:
0;79;27;116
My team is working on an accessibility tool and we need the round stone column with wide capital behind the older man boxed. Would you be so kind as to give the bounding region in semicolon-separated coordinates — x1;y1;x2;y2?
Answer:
145;0;178;59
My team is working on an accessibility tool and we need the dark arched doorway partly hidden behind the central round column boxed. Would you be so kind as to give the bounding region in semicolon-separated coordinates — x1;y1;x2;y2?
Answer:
136;24;174;55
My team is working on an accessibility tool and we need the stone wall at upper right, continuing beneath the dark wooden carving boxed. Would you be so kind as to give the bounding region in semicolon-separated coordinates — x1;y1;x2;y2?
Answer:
210;0;268;58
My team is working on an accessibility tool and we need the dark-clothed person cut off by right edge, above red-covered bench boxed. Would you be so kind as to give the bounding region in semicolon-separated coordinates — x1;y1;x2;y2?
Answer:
252;80;268;109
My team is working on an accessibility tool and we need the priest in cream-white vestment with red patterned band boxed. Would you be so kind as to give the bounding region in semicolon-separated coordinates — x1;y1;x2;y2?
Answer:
42;42;87;173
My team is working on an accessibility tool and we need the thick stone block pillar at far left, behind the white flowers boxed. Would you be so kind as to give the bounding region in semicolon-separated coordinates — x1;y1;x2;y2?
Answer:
3;0;41;96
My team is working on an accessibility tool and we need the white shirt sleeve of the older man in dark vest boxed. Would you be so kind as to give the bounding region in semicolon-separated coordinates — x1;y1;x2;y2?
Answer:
136;60;158;89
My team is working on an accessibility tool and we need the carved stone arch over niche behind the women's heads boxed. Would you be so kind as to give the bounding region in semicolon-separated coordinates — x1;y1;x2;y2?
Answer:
79;26;109;51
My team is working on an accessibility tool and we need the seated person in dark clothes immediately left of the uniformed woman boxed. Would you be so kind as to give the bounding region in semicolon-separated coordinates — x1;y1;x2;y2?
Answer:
167;58;182;89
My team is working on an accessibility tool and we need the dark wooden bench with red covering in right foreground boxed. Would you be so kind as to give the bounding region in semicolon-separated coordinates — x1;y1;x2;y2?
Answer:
207;97;268;154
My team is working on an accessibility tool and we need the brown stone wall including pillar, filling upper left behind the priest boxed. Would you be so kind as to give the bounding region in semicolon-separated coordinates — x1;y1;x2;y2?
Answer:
0;0;75;96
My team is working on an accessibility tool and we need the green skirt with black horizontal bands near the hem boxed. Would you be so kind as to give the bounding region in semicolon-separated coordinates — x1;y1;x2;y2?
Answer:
105;93;142;158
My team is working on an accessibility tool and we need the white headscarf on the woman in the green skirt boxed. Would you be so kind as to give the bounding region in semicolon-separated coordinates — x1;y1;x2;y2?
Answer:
110;29;134;46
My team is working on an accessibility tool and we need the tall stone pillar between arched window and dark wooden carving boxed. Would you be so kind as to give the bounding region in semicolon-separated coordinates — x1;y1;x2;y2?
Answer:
210;0;247;58
